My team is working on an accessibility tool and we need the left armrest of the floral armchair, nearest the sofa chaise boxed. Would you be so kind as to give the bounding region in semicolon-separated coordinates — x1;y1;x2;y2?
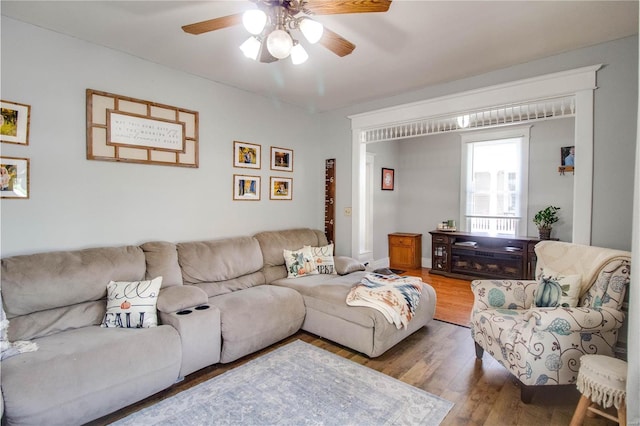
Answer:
471;280;538;312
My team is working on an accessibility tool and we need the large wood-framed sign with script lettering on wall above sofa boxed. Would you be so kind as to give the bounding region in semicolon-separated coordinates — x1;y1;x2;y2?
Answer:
87;89;198;167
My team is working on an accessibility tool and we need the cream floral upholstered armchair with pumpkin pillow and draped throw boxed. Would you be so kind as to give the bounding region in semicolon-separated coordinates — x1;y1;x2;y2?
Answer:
471;241;631;403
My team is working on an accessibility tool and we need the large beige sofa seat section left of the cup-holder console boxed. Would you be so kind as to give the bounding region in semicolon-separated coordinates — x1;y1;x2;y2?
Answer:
2;326;181;425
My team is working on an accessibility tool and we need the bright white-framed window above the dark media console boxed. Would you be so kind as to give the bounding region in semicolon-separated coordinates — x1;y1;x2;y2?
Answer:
460;127;529;235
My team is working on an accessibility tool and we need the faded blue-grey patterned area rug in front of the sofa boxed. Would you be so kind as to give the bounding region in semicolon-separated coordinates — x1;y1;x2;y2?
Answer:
113;340;453;426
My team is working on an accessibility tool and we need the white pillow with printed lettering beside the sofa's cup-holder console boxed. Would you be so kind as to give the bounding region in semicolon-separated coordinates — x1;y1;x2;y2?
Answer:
102;277;162;328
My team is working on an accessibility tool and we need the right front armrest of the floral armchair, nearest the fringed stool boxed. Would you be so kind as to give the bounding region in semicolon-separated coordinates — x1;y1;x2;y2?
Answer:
526;307;624;335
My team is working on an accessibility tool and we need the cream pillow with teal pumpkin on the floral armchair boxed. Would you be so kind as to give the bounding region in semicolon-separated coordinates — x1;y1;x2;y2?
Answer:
533;268;582;308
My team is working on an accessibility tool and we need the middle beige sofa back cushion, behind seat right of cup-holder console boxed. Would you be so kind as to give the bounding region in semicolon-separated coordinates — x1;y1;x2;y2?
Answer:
177;237;264;297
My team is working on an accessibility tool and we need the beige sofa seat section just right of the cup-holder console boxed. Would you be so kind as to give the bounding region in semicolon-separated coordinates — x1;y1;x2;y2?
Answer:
209;285;305;363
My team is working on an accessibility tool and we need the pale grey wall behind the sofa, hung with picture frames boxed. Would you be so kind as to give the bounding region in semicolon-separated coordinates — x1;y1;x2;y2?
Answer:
0;16;324;257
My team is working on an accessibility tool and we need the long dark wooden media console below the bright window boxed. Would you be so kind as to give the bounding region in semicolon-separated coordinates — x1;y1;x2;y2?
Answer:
430;231;540;279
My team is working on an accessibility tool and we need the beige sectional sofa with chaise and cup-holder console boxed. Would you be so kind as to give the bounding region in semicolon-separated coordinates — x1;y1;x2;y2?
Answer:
0;229;435;425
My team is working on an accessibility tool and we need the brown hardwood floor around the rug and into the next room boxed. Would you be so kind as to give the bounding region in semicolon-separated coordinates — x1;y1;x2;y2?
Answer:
91;270;616;426
